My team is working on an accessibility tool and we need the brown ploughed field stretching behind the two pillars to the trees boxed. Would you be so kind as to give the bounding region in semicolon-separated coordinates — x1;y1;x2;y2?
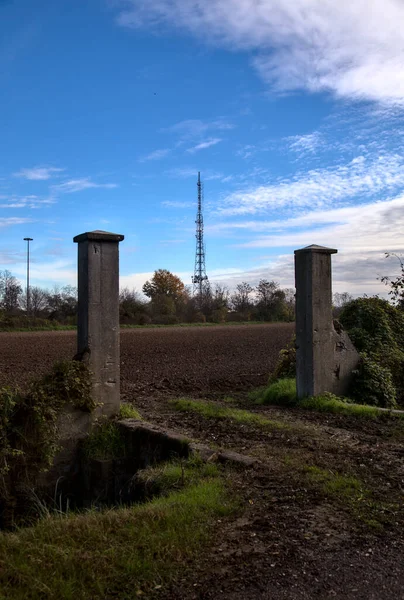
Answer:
0;324;294;399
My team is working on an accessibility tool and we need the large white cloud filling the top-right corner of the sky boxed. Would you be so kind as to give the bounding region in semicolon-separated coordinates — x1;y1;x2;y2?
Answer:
117;0;404;105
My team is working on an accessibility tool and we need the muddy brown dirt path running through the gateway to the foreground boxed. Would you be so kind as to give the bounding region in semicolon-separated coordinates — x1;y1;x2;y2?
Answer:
130;393;404;600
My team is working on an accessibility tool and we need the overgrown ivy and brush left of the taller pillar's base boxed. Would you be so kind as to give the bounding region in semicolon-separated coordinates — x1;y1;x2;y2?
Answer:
0;361;95;525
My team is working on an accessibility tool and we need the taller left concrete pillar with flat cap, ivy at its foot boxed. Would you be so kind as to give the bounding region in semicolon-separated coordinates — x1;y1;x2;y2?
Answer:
73;231;124;416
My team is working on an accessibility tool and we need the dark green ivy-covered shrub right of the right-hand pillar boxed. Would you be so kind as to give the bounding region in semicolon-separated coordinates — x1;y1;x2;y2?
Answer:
339;297;404;407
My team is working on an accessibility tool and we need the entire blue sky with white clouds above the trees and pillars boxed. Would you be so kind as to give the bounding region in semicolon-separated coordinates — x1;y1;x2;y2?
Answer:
0;0;404;294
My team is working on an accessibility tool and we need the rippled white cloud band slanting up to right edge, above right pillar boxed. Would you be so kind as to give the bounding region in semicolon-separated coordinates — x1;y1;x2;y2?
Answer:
219;154;404;215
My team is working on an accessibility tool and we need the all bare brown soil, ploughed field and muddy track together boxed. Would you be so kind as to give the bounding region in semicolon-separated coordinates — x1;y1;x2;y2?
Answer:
0;325;404;600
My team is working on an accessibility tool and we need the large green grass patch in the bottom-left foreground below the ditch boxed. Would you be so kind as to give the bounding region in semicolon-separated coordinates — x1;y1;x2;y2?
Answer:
0;478;238;600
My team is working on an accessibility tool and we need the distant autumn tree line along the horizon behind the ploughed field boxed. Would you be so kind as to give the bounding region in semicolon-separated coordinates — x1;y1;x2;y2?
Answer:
0;269;295;328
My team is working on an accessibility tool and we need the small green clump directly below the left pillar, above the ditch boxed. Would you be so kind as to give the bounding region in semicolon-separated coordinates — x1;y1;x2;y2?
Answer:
83;422;125;460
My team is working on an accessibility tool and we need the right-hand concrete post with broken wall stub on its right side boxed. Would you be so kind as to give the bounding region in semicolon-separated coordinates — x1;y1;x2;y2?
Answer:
295;245;359;398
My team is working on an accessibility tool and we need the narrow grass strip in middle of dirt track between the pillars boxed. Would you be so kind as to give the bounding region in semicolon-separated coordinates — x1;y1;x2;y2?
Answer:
170;398;289;429
